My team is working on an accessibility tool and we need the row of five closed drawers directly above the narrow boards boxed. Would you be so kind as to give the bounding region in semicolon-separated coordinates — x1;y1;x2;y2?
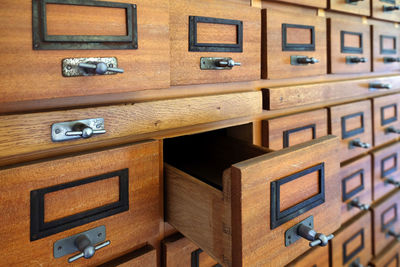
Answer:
1;0;399;105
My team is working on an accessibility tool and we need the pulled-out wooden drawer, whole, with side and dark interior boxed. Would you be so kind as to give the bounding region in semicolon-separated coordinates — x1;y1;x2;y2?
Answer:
164;135;340;266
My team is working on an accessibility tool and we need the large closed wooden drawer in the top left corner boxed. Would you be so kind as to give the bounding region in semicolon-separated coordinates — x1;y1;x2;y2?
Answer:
0;0;170;107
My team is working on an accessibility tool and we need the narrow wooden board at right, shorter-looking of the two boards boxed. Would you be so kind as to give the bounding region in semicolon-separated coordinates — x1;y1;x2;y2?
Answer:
263;77;400;110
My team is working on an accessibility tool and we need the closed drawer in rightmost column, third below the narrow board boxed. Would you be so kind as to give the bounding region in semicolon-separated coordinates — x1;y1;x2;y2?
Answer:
372;191;400;256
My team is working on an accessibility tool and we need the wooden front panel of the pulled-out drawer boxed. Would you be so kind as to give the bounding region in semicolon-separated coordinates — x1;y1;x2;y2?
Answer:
232;137;340;266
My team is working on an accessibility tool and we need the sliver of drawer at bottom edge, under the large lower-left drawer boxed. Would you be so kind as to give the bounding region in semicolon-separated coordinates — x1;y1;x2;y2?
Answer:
99;245;158;267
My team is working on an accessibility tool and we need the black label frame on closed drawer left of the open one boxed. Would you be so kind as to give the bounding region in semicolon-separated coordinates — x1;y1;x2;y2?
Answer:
31;169;129;241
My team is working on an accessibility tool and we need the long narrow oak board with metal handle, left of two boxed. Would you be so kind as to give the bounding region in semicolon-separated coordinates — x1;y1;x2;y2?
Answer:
0;92;261;163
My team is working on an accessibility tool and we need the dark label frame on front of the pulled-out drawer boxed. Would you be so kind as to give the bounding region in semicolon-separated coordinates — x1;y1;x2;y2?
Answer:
271;163;325;229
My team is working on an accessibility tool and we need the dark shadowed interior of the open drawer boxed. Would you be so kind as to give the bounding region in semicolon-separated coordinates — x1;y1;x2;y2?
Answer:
164;127;269;190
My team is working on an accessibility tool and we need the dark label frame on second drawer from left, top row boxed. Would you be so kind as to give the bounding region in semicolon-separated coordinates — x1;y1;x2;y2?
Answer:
189;16;243;52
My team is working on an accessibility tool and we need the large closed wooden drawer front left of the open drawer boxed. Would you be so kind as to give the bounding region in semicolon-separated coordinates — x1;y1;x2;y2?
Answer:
0;141;162;266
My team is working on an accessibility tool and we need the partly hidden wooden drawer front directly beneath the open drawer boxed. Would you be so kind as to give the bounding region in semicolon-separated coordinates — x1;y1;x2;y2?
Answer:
163;234;220;267
